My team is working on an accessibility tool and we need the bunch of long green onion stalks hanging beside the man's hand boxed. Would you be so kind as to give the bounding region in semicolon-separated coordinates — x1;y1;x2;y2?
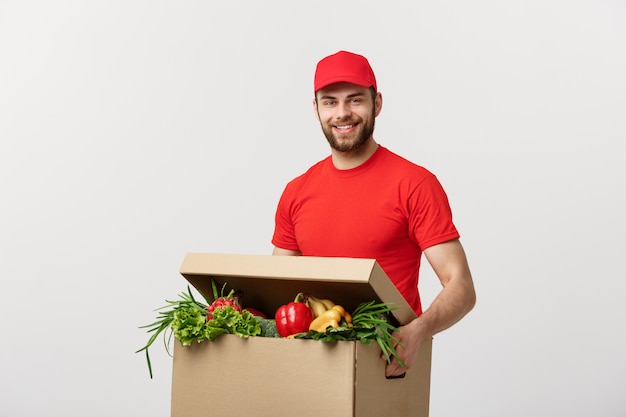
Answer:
296;301;406;367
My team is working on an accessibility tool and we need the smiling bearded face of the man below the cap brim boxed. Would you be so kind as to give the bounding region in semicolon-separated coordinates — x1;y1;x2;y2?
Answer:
313;83;382;152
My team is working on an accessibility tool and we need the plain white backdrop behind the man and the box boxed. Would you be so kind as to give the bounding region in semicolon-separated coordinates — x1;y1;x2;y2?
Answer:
0;0;626;417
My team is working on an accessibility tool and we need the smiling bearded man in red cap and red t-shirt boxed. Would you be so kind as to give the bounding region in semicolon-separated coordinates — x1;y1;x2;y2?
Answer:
272;51;476;376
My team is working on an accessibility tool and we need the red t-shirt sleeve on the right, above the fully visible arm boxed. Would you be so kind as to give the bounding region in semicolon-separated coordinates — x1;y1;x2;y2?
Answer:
409;175;459;250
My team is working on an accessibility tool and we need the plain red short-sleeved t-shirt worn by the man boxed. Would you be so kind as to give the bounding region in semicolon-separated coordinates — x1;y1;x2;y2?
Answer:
272;146;459;315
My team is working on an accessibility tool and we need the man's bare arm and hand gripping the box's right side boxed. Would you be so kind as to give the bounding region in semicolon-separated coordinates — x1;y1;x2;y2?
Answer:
385;239;476;376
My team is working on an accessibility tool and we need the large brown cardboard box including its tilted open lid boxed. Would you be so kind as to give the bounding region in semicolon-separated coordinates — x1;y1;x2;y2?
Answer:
171;253;432;417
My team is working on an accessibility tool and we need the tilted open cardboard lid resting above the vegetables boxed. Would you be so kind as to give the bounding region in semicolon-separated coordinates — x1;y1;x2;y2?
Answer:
180;253;416;324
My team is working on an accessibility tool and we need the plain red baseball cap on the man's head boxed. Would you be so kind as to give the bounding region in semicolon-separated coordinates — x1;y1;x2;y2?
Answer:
314;51;378;92
